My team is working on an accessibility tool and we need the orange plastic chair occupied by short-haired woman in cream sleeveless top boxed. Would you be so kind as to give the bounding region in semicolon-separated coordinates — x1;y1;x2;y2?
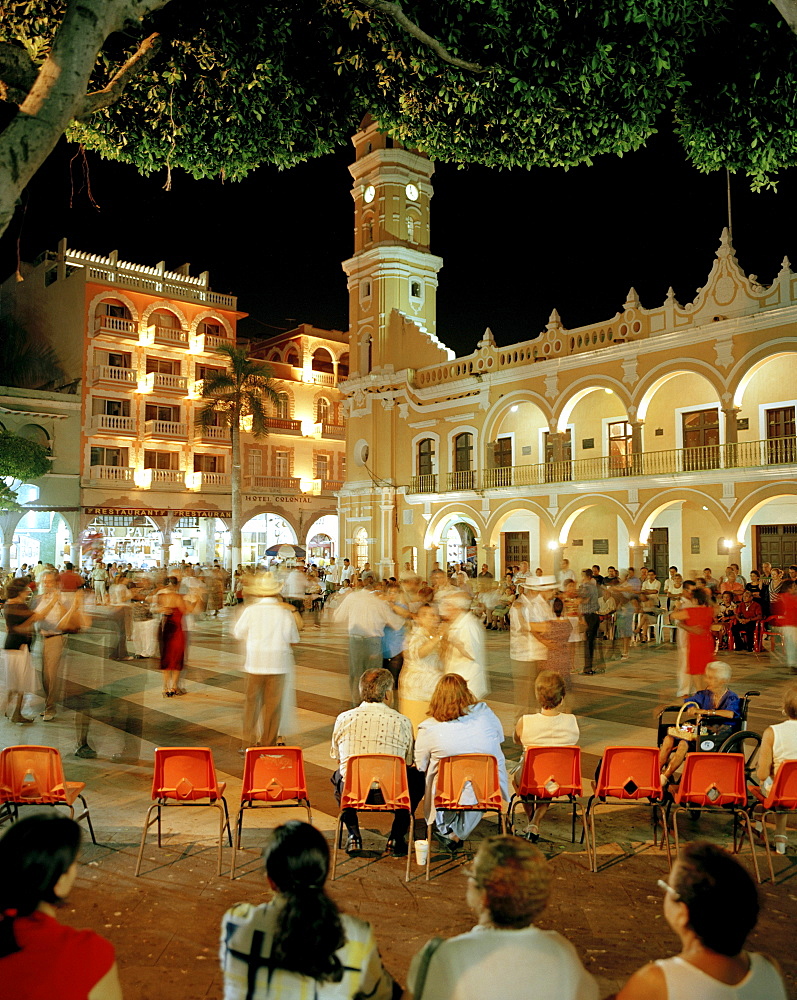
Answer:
506;746;592;869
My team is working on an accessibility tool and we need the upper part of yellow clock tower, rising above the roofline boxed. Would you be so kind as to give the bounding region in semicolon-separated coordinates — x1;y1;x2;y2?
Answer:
343;115;451;376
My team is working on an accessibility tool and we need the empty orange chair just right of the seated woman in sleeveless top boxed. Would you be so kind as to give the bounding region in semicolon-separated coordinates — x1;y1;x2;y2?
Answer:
587;747;664;872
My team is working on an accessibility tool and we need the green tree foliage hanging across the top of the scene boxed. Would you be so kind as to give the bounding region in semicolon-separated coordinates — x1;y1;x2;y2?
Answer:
0;0;797;203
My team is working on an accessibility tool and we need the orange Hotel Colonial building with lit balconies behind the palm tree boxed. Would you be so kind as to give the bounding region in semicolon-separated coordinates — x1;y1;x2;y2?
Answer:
2;241;347;565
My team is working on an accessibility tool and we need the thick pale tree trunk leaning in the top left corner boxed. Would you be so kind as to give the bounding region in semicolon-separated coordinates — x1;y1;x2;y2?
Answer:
0;0;168;236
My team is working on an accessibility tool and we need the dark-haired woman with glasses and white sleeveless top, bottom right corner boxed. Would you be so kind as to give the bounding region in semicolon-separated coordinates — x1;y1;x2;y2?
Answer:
616;841;786;1000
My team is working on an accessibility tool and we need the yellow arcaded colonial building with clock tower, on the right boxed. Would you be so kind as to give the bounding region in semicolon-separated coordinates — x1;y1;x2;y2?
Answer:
340;118;797;575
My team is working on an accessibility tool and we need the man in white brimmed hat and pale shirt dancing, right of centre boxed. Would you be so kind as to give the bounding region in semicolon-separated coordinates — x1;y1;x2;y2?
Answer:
509;576;558;717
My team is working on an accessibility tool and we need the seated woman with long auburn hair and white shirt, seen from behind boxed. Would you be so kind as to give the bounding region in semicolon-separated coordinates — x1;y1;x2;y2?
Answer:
415;674;509;853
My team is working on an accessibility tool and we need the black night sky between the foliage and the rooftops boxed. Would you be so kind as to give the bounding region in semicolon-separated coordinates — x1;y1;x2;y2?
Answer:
0;123;797;354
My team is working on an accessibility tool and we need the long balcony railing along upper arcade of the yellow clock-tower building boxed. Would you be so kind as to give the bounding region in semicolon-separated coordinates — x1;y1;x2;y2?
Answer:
408;437;797;493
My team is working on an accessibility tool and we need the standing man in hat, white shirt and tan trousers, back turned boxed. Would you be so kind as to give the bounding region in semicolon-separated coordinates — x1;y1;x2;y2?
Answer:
233;573;299;753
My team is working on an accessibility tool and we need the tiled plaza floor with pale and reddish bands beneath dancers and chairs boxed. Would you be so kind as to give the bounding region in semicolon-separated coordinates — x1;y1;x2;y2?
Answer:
0;611;797;1000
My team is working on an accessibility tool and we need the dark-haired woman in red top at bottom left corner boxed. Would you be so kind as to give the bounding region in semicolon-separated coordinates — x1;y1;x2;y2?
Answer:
0;813;122;1000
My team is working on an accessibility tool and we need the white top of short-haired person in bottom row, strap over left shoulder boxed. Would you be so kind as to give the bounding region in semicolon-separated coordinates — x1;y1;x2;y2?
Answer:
407;926;596;1000
